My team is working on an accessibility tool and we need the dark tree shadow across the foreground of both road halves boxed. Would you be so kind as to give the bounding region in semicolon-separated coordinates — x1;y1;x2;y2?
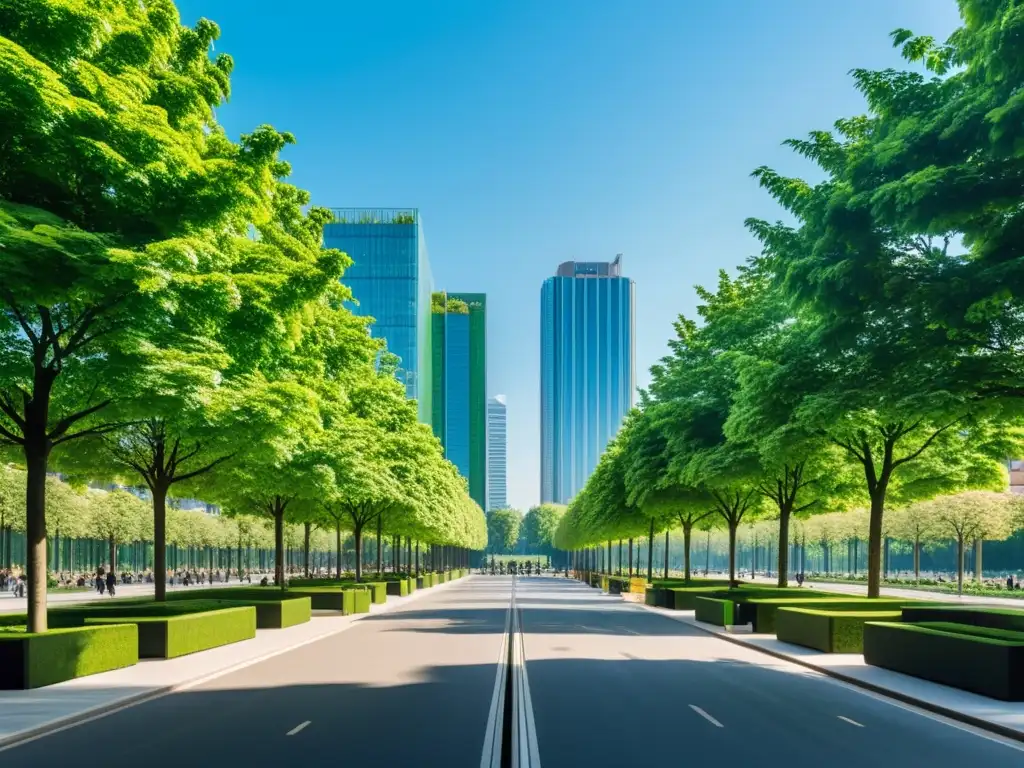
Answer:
0;655;1020;768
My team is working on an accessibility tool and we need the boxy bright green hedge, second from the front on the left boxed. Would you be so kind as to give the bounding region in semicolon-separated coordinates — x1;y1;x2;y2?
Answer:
85;605;256;658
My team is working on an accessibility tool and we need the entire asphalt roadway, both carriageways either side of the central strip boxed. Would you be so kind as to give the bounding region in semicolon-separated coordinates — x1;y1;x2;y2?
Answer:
0;577;1024;768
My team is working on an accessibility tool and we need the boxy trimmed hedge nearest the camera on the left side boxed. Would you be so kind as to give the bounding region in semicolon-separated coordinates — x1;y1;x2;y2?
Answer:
0;624;139;690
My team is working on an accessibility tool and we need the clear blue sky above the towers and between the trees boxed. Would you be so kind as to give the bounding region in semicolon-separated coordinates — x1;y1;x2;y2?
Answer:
178;0;958;518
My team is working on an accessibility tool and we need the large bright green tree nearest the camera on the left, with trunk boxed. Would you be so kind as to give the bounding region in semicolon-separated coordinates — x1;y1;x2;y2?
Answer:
0;3;315;632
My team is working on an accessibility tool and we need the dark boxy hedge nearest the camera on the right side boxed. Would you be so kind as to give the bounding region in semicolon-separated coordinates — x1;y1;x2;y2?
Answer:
864;622;1024;701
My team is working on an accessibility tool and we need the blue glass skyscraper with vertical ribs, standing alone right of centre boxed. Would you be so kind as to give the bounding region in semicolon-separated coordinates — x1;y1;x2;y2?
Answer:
541;256;636;504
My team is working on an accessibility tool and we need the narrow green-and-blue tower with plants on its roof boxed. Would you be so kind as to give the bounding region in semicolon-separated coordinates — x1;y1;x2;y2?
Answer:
430;292;487;508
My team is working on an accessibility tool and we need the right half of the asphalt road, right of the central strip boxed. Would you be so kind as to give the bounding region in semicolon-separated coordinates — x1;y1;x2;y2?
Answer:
516;579;1024;768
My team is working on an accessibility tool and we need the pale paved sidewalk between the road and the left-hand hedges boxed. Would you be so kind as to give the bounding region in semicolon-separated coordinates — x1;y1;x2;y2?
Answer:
0;580;463;749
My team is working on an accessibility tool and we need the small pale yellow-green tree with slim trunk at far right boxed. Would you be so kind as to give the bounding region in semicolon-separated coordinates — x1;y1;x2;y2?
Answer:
922;490;1019;592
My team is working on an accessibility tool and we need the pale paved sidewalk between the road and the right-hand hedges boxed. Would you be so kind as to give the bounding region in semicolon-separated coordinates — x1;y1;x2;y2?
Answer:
639;604;1024;741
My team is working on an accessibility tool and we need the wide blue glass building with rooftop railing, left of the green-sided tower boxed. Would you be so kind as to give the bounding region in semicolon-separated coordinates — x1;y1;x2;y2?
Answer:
324;208;433;423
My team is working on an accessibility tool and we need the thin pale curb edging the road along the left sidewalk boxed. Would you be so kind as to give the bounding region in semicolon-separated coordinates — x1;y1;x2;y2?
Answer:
0;573;469;753
